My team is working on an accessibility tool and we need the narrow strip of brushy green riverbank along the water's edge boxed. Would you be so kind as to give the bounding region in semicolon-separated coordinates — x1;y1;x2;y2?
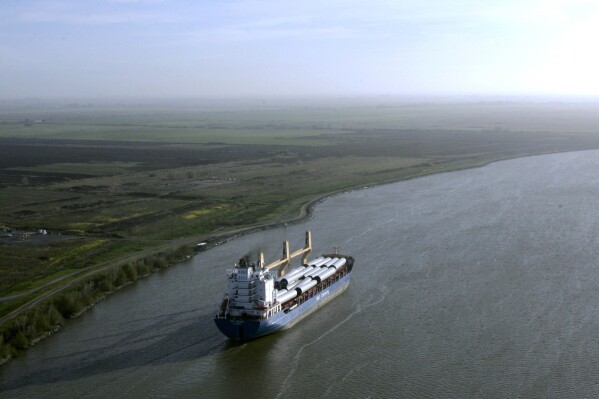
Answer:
0;148;596;365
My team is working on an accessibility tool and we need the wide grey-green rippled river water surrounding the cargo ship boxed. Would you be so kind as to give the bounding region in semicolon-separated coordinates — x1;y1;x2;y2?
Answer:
0;151;599;398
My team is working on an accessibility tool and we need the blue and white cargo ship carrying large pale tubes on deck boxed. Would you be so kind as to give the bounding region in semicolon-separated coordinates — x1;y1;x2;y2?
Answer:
214;231;354;341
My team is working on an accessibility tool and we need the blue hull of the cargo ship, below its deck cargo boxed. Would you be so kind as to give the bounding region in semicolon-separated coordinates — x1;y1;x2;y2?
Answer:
214;273;351;340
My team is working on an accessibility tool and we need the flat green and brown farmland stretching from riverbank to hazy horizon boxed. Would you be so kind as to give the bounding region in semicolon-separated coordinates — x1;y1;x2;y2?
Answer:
0;97;599;362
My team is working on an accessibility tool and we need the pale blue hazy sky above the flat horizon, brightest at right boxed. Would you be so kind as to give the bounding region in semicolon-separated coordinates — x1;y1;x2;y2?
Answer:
0;0;599;99
